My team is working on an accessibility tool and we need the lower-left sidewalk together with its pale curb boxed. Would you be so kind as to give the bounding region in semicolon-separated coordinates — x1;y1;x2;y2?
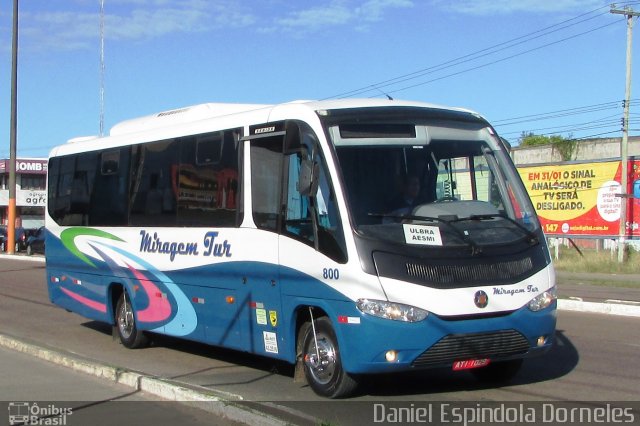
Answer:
0;333;288;426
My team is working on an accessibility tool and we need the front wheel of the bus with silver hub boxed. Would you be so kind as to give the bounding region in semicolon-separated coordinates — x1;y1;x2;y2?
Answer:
300;317;358;398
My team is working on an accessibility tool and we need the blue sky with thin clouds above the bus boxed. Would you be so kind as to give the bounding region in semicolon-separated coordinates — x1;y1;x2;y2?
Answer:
0;0;640;159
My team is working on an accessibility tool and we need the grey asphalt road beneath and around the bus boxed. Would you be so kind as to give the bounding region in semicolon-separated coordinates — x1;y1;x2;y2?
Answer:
0;259;640;425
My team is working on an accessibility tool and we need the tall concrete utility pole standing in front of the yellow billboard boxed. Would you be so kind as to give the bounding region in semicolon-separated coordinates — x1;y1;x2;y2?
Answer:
611;4;640;263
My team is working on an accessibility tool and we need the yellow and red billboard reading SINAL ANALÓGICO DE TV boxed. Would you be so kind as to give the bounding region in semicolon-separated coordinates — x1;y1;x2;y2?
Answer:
518;159;640;238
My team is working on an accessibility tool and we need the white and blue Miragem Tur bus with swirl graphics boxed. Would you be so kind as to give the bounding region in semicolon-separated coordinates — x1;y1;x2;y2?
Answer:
46;99;556;398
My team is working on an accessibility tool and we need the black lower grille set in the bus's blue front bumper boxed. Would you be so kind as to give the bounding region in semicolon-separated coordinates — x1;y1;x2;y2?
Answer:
412;330;529;367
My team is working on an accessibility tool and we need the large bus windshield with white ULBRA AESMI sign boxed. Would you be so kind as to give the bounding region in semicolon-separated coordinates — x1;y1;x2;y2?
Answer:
327;113;540;249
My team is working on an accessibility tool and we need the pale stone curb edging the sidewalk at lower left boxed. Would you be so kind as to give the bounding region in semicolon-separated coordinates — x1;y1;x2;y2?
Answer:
0;334;290;426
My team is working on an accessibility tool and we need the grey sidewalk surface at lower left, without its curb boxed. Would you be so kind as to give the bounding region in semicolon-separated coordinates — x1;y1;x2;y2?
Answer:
0;345;240;426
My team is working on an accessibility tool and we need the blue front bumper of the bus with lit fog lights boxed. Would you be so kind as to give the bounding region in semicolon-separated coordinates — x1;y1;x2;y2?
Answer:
337;302;557;374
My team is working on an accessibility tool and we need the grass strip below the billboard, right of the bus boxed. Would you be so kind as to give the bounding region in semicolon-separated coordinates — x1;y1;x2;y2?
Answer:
551;246;640;274
